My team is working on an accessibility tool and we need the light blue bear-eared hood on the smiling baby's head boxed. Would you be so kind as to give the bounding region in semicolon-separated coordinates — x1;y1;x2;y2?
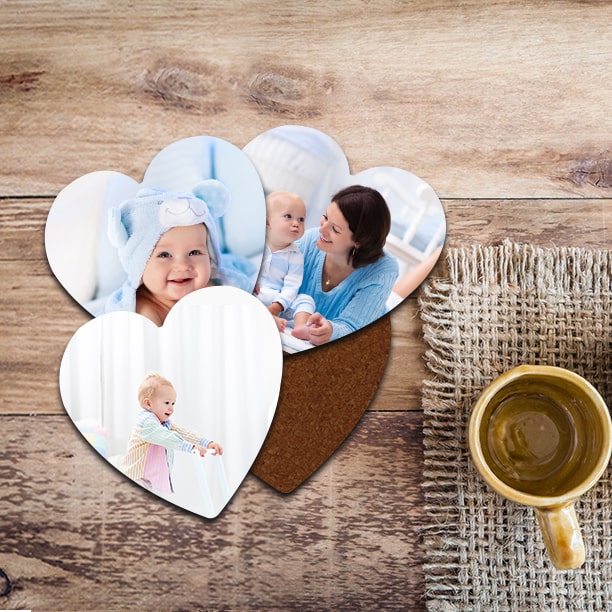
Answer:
106;179;230;311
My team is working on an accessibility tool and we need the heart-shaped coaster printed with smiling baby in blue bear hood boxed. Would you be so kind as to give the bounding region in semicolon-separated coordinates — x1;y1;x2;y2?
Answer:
45;136;266;316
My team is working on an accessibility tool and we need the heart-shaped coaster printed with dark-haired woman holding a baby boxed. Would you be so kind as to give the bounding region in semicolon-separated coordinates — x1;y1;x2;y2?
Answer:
244;125;446;353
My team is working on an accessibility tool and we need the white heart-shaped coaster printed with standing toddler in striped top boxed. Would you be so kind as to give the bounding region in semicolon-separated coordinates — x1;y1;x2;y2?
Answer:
60;287;283;518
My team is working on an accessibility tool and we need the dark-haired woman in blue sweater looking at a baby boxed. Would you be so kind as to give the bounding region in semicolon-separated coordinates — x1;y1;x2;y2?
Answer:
293;185;398;345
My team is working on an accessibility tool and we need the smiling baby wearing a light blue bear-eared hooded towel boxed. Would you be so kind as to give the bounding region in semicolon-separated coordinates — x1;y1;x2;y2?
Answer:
104;179;252;325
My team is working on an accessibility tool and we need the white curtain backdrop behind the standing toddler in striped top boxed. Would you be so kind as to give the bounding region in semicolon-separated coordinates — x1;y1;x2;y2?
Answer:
60;287;282;515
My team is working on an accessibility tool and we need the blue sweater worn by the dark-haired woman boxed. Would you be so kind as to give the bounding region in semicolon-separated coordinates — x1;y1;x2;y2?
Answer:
293;227;399;340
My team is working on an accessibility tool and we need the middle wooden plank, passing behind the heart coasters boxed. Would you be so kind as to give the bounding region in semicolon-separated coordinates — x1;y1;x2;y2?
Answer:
0;199;612;414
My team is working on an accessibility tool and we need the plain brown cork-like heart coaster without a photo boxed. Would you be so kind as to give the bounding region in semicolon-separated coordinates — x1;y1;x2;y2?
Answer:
251;315;391;493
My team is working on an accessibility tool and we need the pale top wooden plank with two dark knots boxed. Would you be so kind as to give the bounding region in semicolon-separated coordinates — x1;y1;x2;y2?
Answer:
0;0;612;198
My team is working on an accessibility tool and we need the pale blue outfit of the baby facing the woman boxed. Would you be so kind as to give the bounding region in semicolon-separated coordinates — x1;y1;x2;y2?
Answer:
257;243;304;310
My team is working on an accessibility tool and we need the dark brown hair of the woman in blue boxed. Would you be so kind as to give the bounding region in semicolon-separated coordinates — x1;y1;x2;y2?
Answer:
331;185;391;268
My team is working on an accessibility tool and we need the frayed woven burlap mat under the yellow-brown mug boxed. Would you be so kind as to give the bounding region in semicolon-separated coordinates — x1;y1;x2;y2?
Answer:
420;241;612;612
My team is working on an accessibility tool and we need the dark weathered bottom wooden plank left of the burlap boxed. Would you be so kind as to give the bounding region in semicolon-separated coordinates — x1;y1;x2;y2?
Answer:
0;413;423;610
